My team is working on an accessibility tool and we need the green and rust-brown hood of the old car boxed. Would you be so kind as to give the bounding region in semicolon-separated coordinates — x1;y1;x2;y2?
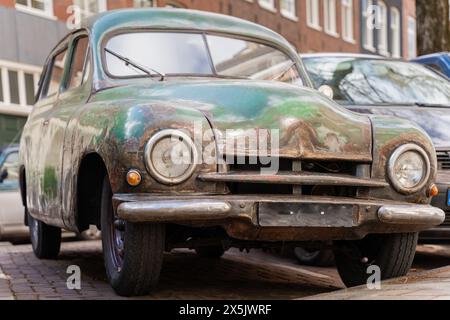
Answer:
95;79;372;161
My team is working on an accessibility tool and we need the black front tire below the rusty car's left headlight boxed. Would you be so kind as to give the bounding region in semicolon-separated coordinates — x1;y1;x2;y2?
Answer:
101;177;165;297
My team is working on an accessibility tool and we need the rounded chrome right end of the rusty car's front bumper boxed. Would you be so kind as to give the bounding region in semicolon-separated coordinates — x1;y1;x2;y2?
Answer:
378;205;445;226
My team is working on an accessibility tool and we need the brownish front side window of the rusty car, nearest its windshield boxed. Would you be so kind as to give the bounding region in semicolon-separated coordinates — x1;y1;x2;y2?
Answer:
67;36;89;90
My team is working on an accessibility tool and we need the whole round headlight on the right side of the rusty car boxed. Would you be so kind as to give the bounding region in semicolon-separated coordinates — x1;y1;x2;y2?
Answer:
388;144;431;193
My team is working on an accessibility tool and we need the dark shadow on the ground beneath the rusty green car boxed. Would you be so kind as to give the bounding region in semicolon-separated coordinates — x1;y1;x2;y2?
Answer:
52;245;340;299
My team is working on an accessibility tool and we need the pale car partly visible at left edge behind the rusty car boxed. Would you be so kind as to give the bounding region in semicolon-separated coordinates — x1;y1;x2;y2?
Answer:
0;145;29;241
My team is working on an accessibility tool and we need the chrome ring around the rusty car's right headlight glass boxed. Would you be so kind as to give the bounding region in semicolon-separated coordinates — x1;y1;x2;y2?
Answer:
387;143;431;194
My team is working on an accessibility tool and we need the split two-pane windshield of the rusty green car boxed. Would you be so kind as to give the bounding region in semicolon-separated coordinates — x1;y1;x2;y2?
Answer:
105;32;302;84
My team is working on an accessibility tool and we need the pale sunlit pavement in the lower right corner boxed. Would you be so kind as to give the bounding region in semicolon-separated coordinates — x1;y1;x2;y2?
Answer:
304;245;450;300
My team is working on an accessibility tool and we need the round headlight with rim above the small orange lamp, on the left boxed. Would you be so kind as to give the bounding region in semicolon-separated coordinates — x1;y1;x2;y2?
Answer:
145;130;198;185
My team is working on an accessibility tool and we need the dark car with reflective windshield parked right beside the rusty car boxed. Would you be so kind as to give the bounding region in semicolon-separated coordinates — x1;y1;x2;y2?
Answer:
296;53;450;264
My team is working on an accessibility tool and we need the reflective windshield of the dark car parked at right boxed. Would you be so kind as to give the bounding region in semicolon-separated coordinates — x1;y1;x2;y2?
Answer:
303;57;450;106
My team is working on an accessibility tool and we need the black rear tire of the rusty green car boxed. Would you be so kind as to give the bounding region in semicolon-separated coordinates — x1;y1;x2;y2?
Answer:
27;213;61;260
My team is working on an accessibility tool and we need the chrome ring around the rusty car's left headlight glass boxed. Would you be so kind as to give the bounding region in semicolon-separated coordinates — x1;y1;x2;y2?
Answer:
144;129;198;185
